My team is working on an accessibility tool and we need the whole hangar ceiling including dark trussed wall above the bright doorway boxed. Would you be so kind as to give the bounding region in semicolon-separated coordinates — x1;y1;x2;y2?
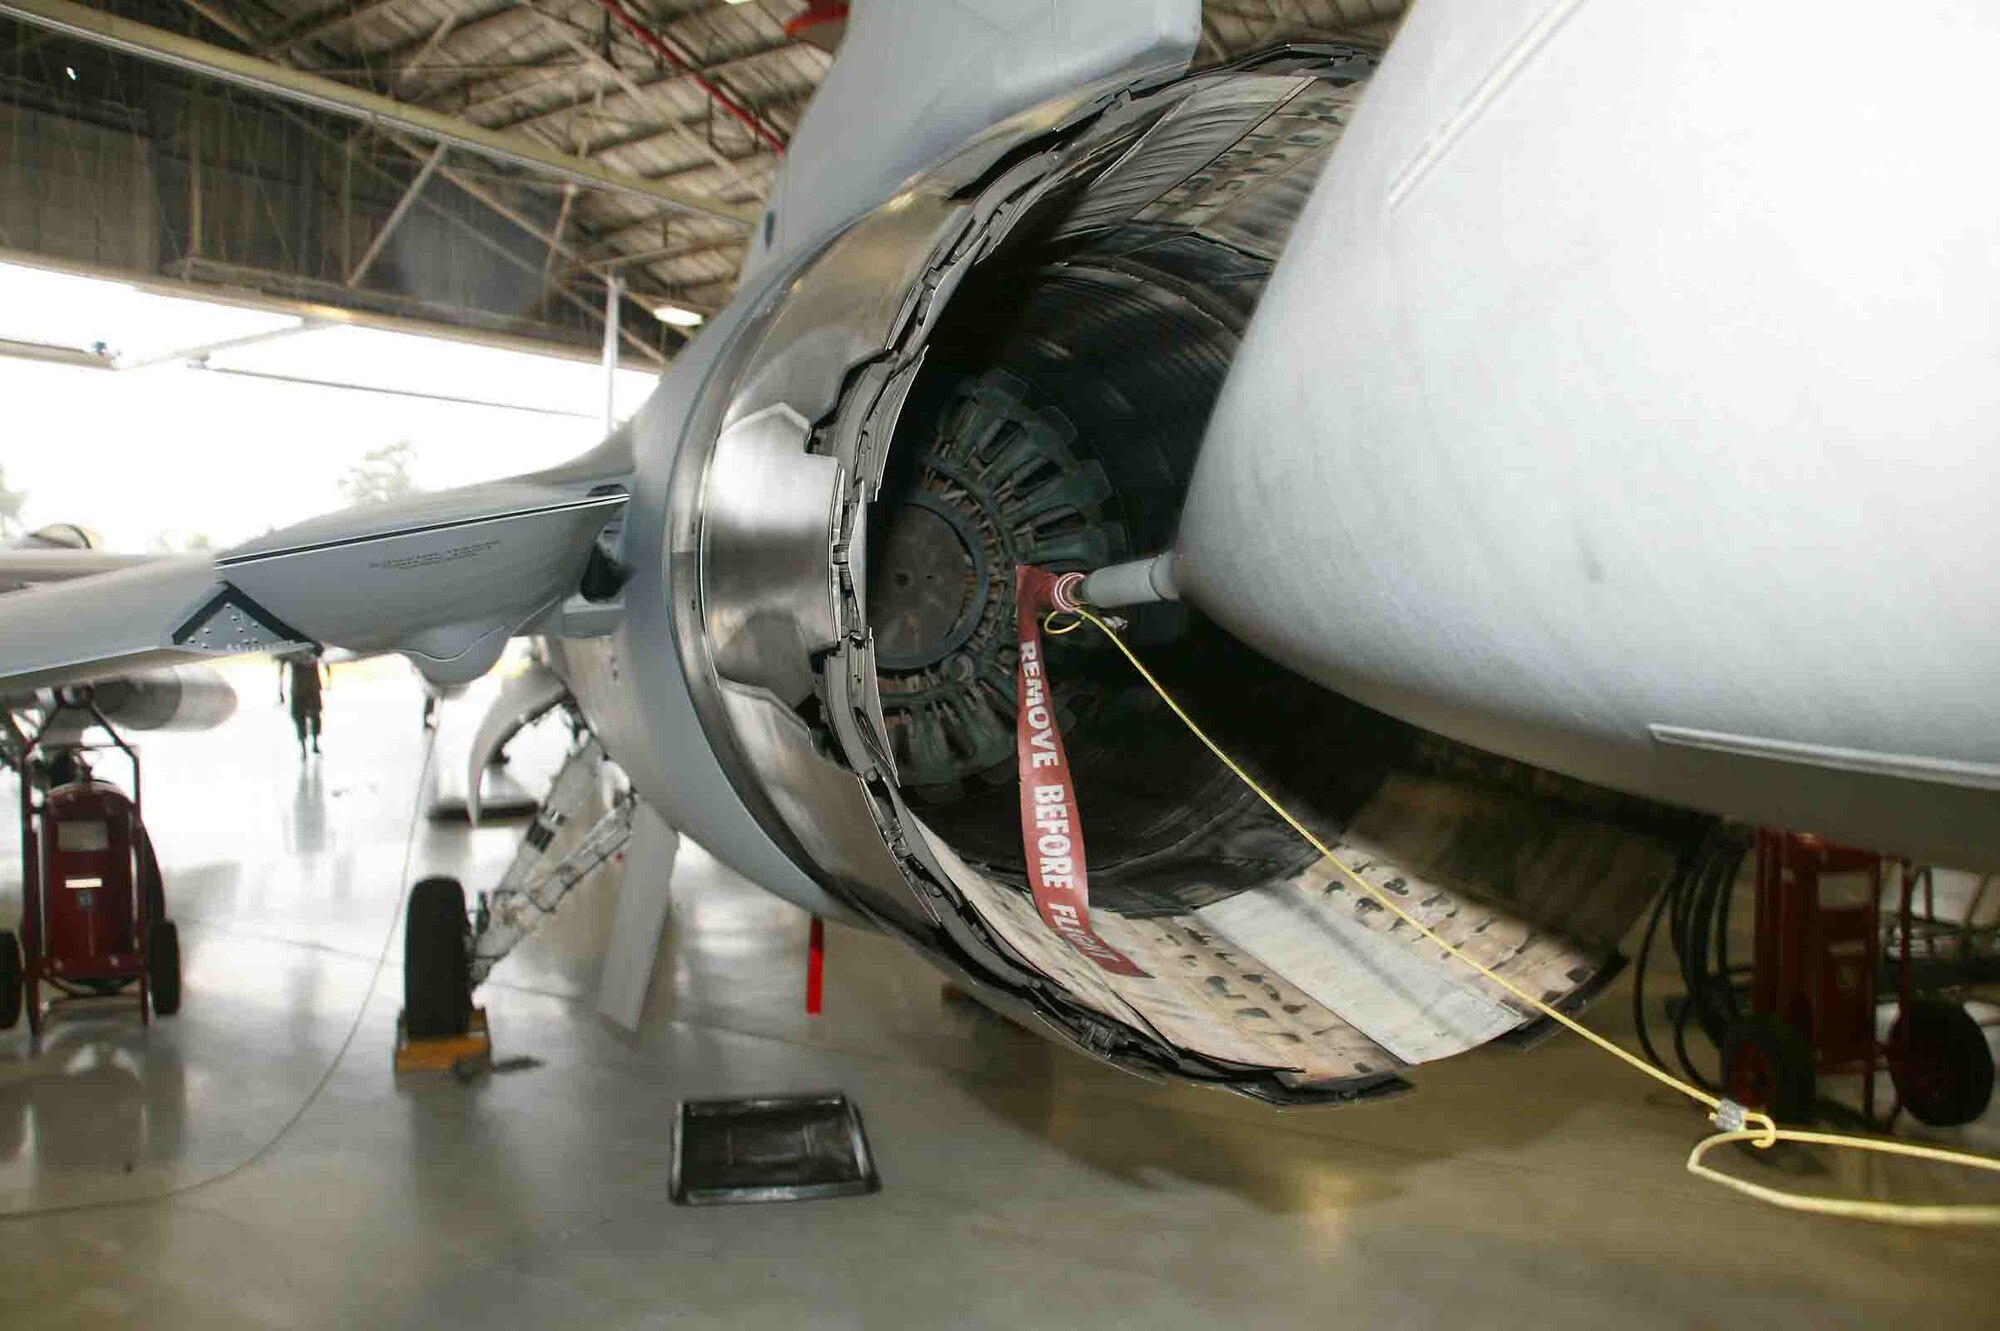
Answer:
0;0;1404;362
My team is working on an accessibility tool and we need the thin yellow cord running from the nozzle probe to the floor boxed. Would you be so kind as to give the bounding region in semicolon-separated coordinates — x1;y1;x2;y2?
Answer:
1042;610;2000;1225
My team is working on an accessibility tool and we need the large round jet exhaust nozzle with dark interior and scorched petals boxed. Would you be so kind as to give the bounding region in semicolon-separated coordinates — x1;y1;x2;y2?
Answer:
676;46;1716;1103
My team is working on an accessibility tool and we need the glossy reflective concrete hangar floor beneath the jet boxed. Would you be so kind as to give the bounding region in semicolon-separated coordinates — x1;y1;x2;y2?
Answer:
0;666;2000;1329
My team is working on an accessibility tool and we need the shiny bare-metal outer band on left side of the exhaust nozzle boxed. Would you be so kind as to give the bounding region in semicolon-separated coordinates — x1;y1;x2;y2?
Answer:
666;175;1016;929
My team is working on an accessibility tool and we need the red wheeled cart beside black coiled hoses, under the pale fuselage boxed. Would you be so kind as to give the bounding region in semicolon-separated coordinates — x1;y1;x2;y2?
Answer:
1722;827;1994;1127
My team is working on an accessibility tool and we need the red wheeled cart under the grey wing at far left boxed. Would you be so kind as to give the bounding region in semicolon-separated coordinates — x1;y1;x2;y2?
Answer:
0;695;180;1033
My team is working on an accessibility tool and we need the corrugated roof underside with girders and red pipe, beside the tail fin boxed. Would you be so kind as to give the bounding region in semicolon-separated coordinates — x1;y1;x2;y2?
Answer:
184;0;1404;308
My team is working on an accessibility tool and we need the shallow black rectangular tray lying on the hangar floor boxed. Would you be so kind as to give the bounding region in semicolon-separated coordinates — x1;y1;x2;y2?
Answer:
672;1091;882;1207
